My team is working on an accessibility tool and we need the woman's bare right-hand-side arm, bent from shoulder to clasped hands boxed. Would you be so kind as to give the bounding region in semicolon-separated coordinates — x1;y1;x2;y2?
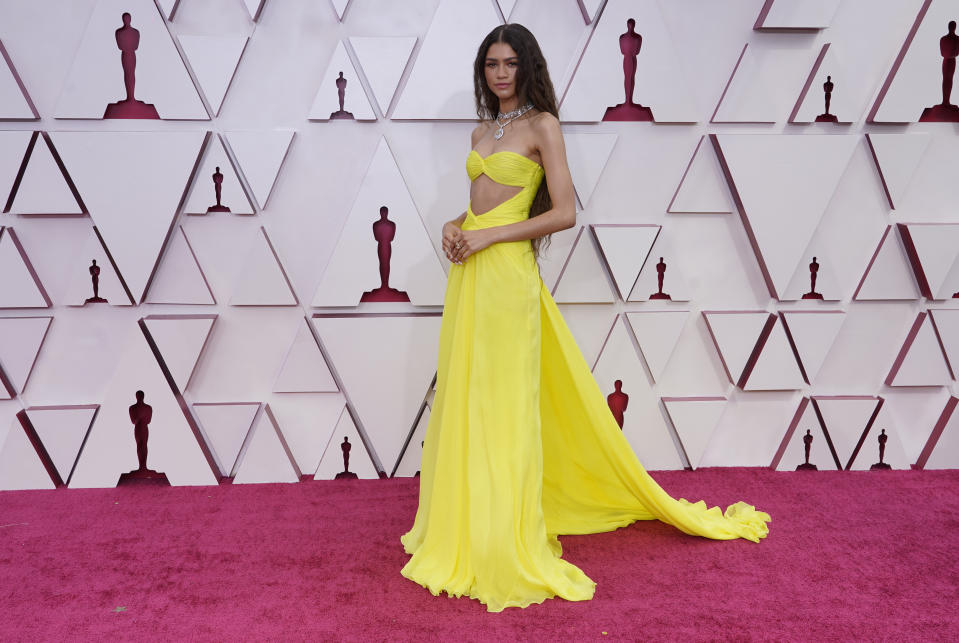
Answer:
452;114;576;261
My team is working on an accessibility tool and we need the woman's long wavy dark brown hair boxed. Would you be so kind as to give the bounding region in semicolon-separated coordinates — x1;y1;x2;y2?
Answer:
473;22;559;258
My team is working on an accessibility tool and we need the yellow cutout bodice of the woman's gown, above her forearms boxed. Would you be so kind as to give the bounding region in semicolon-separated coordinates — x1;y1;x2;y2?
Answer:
463;150;545;230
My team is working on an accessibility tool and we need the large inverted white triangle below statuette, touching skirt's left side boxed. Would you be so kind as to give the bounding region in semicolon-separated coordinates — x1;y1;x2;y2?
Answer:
313;313;442;468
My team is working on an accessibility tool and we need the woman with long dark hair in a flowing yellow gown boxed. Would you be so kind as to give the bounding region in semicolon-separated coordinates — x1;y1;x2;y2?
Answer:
402;24;769;611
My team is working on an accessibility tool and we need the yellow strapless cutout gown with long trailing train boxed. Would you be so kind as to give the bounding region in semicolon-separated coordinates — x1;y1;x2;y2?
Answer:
401;150;770;612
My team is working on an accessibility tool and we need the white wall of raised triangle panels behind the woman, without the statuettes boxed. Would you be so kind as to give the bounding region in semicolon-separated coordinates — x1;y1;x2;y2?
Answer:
0;0;959;489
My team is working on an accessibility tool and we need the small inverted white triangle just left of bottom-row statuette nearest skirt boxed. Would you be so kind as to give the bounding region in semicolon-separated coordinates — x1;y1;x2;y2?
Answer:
270;395;344;474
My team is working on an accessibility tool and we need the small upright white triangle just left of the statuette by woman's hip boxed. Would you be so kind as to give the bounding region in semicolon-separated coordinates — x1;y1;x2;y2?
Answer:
230;226;298;306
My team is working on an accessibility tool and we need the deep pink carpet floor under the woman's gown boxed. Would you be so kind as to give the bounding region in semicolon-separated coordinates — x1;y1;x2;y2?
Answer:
0;469;959;640
